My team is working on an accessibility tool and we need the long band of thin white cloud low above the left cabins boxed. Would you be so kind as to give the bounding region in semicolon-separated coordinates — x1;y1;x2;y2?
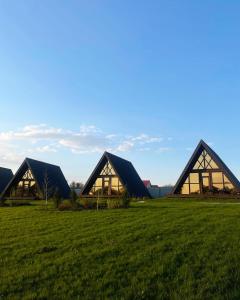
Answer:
0;124;166;166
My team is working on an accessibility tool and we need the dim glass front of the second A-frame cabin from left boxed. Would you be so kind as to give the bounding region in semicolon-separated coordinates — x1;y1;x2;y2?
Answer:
10;170;38;198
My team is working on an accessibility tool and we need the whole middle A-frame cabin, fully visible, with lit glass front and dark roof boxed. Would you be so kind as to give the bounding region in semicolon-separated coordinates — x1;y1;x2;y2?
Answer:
81;152;151;198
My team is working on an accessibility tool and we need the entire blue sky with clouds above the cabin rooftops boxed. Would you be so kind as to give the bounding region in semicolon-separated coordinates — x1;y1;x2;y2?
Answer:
0;0;240;184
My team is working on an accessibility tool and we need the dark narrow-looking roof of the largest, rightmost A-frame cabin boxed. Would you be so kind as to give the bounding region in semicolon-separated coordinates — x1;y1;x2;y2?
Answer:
173;140;240;194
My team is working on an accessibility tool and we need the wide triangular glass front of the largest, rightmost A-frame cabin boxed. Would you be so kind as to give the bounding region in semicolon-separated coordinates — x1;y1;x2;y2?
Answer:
180;150;235;195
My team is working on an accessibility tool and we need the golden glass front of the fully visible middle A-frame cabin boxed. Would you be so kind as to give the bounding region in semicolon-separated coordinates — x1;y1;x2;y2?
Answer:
89;162;125;197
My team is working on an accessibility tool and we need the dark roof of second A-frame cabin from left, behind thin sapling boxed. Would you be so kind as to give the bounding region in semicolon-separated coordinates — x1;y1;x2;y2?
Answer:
1;158;70;198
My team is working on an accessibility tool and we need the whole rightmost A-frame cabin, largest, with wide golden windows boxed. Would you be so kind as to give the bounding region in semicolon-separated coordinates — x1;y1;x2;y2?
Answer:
173;140;240;196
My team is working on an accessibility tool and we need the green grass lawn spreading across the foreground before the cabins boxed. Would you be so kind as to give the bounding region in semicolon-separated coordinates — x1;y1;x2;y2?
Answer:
0;199;240;300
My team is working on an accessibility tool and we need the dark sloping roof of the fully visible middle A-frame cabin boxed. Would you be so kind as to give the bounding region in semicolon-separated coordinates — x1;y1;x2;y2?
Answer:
81;152;151;198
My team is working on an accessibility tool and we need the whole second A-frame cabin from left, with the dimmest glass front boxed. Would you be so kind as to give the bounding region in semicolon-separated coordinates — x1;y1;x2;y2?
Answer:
1;158;70;201
